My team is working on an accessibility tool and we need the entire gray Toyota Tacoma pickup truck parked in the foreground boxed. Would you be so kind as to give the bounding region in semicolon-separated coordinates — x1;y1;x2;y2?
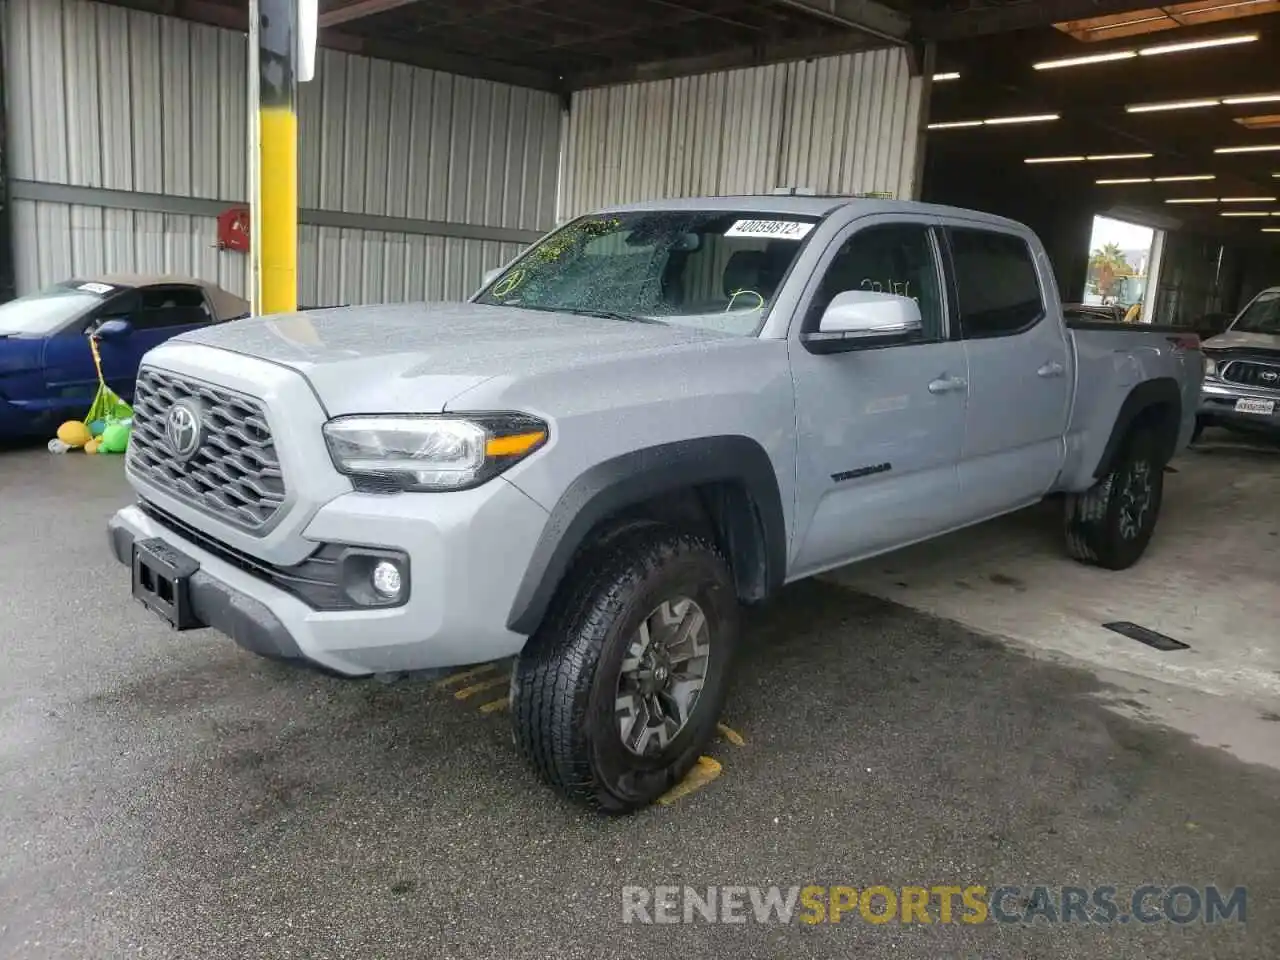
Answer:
110;196;1203;812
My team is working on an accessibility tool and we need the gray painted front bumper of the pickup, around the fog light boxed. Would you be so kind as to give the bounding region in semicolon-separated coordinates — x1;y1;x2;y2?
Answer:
108;477;547;676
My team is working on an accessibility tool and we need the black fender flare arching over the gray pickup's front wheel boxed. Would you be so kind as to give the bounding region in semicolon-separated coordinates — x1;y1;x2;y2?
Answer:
507;435;786;636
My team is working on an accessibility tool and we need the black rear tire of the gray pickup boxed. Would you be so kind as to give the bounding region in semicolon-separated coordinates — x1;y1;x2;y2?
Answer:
1065;428;1165;570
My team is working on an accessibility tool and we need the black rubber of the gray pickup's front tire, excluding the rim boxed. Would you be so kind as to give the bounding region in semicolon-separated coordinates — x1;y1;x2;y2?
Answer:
511;525;739;813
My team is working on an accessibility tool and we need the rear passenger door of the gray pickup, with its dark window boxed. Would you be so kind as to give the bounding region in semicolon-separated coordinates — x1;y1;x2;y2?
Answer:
946;224;1074;520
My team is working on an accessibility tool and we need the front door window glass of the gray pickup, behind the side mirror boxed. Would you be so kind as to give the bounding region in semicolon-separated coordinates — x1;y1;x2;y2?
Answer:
809;224;946;343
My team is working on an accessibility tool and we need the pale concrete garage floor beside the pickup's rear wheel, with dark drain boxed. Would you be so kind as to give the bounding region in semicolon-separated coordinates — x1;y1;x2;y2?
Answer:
831;430;1280;767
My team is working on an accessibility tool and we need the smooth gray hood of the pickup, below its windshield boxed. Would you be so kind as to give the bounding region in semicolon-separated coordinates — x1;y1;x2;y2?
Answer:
174;303;730;416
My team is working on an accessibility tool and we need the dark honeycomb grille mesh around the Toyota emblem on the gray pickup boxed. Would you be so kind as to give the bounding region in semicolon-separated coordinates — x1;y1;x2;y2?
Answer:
129;367;284;534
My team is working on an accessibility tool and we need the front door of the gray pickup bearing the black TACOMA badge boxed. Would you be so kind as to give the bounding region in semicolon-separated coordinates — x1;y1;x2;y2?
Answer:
790;218;968;575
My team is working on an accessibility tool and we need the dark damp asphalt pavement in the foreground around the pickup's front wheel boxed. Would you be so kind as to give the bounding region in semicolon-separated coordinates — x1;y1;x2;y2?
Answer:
0;437;1280;960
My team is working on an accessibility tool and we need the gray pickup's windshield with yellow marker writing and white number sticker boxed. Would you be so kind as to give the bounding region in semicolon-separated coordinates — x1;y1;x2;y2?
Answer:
476;210;818;337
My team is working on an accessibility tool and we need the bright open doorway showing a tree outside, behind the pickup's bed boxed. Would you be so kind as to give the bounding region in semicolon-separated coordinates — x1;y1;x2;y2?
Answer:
1080;214;1164;323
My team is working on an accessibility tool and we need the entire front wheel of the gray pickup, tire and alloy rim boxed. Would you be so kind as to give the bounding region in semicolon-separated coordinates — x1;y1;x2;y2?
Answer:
511;525;739;813
